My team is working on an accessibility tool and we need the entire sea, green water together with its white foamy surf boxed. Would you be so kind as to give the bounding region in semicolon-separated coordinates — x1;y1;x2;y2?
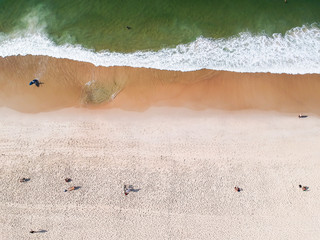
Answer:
0;0;320;74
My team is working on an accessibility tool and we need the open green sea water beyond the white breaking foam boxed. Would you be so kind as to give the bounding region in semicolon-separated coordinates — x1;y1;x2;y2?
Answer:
0;0;320;52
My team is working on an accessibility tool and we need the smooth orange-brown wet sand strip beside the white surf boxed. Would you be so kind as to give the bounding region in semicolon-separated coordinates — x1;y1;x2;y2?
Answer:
0;56;320;114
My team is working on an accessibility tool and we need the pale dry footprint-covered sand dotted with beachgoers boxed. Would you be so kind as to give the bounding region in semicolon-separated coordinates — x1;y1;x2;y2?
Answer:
0;108;320;240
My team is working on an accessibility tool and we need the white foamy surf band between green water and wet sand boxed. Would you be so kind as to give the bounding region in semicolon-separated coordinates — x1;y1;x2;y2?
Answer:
0;25;320;74
